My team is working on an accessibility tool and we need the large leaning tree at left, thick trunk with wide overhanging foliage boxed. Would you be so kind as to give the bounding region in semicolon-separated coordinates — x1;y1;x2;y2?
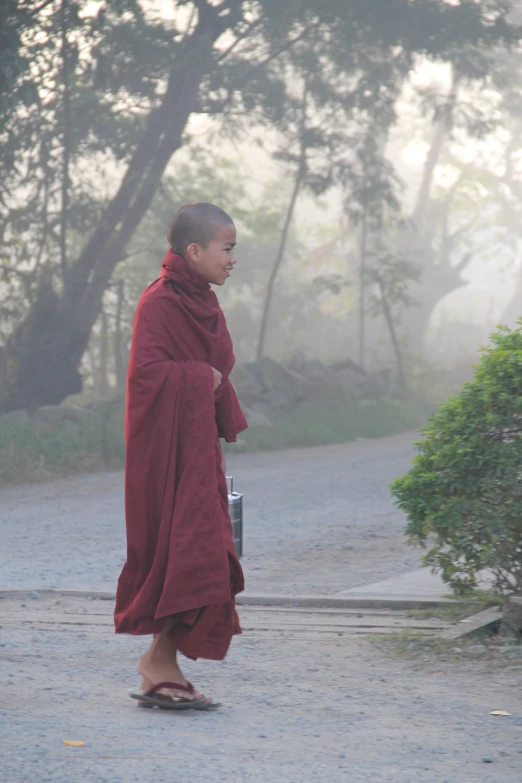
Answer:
0;0;516;410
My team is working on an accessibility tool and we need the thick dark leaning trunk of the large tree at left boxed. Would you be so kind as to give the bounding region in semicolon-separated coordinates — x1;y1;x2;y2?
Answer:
0;12;221;412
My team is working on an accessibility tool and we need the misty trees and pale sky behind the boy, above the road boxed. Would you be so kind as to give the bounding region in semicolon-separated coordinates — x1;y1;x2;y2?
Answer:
0;0;522;475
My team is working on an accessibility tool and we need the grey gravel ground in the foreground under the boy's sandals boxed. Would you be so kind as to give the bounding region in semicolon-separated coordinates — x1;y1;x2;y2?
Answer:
0;600;522;783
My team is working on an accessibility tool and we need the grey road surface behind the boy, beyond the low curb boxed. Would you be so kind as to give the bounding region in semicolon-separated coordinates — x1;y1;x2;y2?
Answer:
0;435;419;594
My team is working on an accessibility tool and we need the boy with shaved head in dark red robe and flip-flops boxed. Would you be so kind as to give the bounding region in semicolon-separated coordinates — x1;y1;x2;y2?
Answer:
114;203;247;709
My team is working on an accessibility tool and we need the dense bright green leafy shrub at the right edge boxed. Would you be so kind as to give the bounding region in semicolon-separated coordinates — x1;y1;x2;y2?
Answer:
392;322;522;594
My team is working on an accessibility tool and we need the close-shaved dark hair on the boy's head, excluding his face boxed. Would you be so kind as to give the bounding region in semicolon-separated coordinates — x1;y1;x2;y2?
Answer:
167;201;234;256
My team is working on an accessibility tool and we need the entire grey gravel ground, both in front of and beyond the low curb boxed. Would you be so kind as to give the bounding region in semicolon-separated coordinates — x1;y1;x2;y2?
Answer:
0;436;522;783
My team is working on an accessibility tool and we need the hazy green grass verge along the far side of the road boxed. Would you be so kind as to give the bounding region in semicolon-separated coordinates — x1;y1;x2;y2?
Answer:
0;376;442;486
